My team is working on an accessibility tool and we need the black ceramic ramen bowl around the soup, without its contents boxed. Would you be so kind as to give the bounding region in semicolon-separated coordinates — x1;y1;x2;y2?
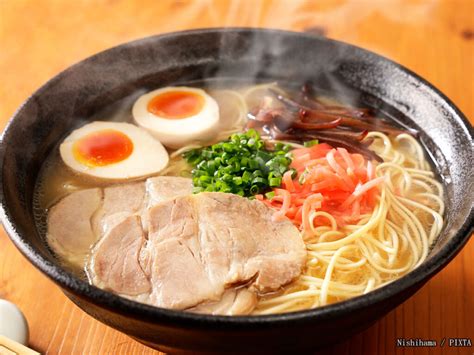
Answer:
0;29;474;352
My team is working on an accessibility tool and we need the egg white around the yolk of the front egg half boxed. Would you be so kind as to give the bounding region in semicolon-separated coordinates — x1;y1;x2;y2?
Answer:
59;121;169;180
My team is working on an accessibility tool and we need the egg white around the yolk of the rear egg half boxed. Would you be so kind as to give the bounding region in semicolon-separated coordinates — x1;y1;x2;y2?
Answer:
132;86;219;149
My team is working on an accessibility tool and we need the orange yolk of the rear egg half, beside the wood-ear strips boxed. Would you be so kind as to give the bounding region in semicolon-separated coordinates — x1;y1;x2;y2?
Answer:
147;91;204;119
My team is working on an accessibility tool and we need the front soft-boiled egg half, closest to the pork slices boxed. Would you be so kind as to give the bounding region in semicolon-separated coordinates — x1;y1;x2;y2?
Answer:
59;121;169;180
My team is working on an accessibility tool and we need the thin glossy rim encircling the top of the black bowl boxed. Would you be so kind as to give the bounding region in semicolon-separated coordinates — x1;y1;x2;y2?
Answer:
0;27;474;329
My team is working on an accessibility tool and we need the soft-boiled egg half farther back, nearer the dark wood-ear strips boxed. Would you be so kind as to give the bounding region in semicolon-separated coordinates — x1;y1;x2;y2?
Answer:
132;86;219;149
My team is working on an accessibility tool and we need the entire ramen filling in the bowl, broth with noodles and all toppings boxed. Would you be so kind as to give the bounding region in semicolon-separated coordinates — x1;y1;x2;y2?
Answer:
34;81;444;315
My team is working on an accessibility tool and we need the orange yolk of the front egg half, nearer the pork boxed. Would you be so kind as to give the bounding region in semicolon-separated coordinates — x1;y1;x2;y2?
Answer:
72;129;133;167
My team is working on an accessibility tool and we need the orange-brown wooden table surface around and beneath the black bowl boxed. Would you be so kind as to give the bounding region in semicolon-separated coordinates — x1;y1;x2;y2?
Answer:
0;0;474;354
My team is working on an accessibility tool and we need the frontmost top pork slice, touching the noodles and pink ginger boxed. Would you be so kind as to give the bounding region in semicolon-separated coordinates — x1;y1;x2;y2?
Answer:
148;192;306;308
